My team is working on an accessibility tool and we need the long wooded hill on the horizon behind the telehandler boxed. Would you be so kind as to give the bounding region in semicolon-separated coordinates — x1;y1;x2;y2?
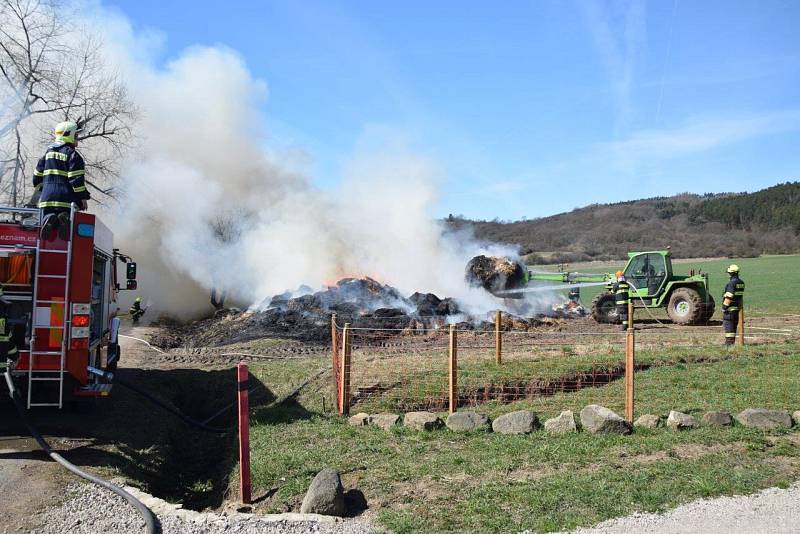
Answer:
446;182;800;263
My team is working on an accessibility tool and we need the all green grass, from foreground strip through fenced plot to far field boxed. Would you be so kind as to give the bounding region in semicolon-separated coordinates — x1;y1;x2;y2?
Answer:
239;256;800;532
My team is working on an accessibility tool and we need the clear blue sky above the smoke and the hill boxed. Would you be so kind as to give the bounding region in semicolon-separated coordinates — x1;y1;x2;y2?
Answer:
105;0;800;220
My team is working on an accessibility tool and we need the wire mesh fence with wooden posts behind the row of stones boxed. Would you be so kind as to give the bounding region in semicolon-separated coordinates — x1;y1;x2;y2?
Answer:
331;314;798;418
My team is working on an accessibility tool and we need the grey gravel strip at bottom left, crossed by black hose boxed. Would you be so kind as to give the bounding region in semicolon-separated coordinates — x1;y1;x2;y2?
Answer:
36;481;375;534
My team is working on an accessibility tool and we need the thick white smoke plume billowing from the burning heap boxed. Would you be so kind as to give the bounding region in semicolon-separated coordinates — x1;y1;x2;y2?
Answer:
86;8;536;317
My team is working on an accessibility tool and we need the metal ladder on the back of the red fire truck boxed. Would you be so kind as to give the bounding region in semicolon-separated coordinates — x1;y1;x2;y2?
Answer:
28;206;75;409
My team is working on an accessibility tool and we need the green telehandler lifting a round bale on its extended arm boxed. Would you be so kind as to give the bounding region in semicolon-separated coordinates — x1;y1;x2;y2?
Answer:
466;249;716;325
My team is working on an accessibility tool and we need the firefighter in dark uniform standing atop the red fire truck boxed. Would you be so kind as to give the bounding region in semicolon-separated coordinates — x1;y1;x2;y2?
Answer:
33;121;90;240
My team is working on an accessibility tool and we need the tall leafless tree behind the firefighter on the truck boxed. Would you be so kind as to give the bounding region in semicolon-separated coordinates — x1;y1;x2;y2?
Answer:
0;0;136;205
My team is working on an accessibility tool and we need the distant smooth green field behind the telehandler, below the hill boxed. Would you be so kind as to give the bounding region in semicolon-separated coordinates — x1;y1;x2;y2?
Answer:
537;255;800;317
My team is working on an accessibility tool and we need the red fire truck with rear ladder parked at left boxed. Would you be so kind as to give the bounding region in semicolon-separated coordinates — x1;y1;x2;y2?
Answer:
0;206;136;408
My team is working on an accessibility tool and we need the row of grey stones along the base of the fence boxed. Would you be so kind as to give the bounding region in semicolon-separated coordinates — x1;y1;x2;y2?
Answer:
348;410;800;434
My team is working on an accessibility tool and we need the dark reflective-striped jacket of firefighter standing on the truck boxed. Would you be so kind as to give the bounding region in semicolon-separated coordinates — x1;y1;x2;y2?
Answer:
33;144;90;209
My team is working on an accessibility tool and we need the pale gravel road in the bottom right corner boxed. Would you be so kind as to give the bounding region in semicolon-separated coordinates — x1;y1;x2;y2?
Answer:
573;483;800;534
